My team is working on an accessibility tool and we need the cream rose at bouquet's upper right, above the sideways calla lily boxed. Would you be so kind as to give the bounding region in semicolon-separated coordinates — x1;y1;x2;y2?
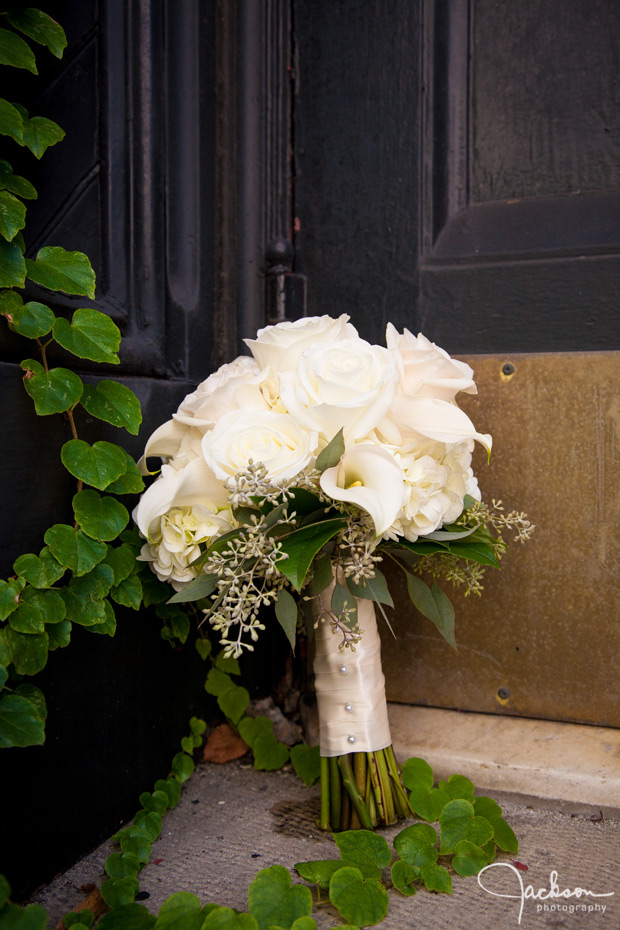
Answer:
386;323;478;400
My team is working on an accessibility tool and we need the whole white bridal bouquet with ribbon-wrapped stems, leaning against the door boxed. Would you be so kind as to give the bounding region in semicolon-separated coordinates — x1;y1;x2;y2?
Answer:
134;315;531;830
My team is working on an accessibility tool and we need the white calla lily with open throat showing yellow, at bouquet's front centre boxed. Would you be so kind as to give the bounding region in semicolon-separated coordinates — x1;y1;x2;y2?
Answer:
320;443;405;536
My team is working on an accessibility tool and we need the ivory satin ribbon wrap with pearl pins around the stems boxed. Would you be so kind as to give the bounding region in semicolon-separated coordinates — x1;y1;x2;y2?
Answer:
314;587;392;757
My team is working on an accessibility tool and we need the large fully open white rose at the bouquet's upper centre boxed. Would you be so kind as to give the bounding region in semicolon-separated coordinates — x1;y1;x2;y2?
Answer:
280;337;398;440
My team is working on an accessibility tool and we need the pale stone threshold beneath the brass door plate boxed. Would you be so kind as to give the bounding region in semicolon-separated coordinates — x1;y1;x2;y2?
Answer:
388;704;620;810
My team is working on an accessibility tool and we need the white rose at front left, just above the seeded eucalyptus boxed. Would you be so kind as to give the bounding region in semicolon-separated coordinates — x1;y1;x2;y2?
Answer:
202;410;318;481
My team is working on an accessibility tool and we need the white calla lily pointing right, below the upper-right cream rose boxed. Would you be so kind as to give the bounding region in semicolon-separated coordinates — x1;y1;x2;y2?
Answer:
390;394;493;453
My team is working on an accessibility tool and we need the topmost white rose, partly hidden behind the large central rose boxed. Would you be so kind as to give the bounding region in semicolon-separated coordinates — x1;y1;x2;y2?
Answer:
243;313;357;372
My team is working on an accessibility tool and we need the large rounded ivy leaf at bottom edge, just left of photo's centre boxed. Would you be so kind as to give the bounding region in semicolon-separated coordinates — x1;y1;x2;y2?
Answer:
248;865;312;930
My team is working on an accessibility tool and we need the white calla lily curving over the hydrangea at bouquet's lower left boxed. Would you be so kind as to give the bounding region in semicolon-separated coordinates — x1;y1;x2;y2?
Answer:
133;458;228;539
